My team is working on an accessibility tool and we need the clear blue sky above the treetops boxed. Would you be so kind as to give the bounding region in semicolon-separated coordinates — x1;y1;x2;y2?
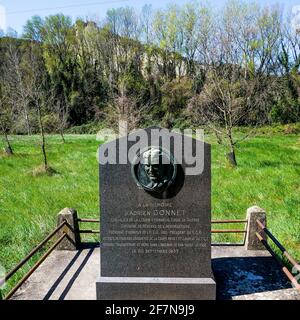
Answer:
0;0;300;33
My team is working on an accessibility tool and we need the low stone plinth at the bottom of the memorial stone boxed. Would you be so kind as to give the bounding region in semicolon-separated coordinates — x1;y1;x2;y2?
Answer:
96;277;216;300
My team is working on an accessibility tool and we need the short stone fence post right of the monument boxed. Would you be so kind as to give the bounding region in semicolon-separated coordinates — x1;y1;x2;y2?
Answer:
246;206;267;250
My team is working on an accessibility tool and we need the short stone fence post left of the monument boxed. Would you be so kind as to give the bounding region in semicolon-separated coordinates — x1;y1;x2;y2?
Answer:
56;208;81;251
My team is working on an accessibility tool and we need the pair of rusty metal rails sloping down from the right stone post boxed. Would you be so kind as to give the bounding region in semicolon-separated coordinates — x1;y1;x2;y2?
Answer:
256;220;300;291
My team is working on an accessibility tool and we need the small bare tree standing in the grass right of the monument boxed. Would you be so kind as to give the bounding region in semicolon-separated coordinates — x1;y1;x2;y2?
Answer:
188;70;269;166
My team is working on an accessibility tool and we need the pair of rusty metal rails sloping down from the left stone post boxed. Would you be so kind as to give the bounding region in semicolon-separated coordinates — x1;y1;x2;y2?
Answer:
0;221;71;300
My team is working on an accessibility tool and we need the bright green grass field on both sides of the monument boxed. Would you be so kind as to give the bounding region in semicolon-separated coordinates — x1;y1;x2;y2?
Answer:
0;130;300;298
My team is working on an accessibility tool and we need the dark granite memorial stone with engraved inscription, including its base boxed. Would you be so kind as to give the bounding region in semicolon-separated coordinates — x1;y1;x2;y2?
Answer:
97;129;216;300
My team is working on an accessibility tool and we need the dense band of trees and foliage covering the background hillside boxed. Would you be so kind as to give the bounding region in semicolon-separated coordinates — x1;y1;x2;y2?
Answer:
0;0;299;133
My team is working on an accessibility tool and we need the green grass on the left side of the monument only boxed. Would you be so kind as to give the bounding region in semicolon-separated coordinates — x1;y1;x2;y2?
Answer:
0;136;99;296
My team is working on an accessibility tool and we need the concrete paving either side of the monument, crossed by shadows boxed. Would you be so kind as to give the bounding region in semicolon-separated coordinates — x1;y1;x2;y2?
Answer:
13;246;300;300
